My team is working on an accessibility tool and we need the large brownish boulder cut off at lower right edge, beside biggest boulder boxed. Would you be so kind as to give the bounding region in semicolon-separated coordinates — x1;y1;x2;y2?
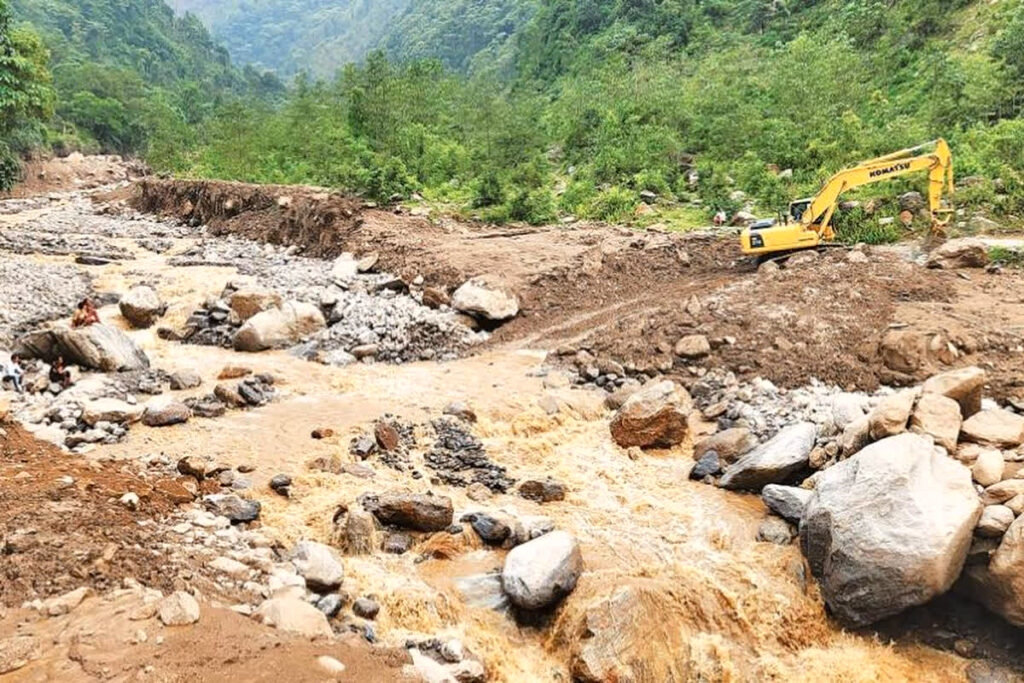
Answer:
964;516;1024;627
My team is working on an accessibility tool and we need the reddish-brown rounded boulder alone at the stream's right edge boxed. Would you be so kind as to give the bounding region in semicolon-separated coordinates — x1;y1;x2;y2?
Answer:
611;380;691;449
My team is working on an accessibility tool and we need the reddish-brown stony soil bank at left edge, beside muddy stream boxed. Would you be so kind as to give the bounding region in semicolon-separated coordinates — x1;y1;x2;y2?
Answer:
0;422;182;606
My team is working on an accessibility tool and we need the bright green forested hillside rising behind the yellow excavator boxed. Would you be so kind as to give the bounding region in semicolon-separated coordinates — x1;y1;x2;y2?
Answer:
9;0;1024;232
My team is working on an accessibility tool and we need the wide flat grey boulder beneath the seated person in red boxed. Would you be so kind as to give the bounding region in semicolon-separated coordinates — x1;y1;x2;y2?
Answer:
13;324;150;373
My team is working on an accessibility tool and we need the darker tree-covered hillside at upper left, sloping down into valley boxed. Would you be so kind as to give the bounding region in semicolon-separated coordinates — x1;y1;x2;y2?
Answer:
3;0;284;176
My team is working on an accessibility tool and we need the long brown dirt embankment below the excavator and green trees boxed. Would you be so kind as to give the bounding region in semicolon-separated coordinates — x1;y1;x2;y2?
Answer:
132;179;1024;397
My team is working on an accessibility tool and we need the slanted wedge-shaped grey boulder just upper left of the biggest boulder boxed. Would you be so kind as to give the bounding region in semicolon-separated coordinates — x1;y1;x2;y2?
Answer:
718;422;817;492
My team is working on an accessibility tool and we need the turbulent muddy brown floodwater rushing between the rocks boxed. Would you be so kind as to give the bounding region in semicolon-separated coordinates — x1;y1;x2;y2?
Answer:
8;191;966;681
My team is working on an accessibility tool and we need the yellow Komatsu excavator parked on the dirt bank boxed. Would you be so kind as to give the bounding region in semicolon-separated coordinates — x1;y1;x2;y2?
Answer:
739;139;953;260
